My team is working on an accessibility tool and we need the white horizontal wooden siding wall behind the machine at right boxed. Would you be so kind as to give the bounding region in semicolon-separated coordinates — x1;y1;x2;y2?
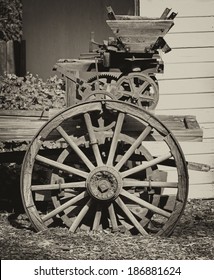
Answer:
140;0;214;198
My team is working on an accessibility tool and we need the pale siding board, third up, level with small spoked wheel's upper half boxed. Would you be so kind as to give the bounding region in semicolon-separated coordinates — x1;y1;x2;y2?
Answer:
159;78;214;94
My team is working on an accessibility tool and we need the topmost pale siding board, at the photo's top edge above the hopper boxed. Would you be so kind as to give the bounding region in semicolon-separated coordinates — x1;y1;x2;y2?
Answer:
140;0;214;17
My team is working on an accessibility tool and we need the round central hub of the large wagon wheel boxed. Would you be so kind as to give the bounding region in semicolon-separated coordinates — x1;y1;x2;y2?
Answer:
87;166;122;201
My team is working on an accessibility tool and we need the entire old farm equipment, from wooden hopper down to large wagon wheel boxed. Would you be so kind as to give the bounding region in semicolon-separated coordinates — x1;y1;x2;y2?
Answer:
1;8;210;235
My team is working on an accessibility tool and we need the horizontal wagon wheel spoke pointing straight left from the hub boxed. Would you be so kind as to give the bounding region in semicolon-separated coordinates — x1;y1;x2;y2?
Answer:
31;181;86;191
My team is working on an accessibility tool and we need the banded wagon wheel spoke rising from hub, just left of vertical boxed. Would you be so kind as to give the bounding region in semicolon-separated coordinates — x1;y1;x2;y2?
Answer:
84;113;103;166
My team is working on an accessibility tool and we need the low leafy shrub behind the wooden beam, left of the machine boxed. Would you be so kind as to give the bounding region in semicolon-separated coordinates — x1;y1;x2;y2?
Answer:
0;73;65;110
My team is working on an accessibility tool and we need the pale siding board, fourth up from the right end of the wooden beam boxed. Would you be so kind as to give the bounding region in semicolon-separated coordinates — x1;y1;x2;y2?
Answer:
155;62;214;82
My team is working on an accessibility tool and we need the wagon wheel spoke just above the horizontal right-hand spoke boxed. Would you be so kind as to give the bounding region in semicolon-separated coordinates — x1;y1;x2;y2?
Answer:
121;153;172;178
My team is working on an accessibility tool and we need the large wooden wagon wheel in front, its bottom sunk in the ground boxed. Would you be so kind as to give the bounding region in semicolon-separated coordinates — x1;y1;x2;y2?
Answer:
21;100;188;235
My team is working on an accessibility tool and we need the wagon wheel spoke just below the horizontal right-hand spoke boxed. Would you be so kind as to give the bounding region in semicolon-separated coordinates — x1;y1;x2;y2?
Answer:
121;189;171;218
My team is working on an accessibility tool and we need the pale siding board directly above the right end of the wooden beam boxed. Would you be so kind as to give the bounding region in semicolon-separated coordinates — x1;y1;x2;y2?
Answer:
155;107;214;125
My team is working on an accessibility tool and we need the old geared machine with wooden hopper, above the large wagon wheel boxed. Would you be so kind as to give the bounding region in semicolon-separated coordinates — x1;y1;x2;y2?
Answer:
57;7;176;109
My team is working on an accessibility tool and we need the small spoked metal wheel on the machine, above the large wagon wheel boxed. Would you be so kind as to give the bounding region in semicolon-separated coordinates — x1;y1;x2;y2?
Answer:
116;72;159;110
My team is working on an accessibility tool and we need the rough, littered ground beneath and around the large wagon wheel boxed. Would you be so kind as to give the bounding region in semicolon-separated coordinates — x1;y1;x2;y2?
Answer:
0;200;214;260
